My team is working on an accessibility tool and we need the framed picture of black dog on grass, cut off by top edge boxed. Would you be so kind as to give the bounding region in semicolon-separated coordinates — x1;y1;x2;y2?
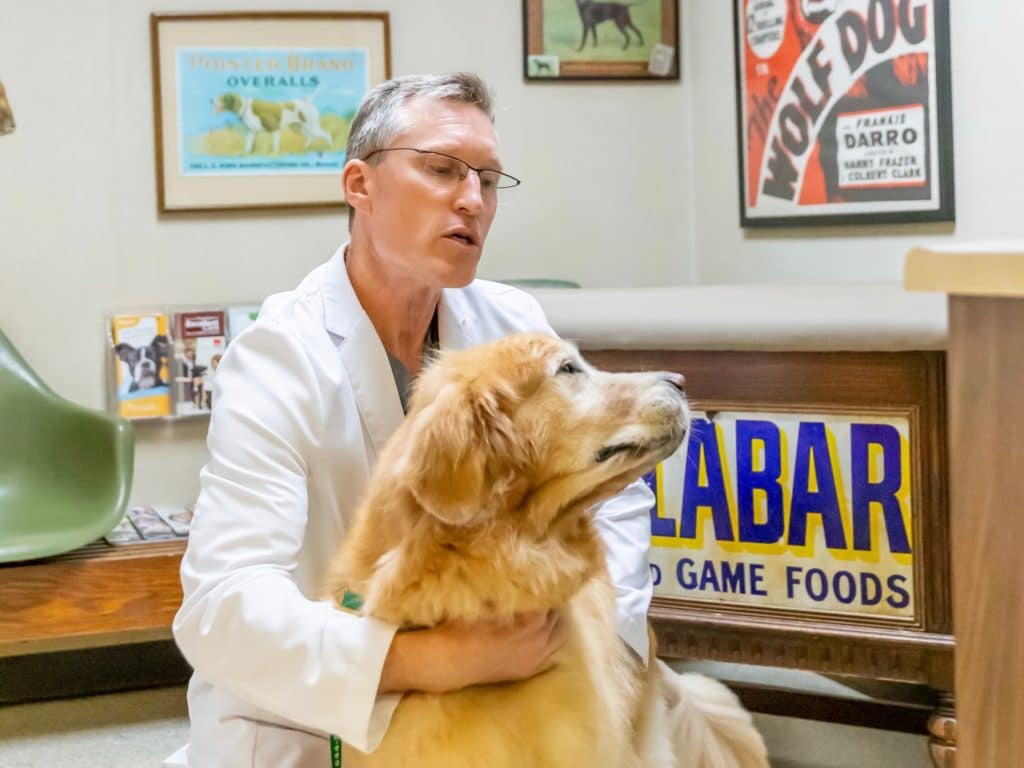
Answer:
522;0;679;82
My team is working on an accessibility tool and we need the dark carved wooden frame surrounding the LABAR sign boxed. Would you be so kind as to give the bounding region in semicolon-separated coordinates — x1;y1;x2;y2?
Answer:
587;350;953;691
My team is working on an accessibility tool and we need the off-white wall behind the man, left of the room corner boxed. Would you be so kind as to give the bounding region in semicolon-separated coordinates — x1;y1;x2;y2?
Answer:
0;0;690;504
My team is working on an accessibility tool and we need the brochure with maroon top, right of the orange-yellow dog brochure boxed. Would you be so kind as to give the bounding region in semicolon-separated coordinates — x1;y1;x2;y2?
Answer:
174;309;227;416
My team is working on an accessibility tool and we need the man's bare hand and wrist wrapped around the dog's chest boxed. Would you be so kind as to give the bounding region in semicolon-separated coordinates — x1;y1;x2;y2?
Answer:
379;611;568;693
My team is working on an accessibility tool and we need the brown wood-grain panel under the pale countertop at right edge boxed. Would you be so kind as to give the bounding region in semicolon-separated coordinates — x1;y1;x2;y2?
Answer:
949;296;1024;768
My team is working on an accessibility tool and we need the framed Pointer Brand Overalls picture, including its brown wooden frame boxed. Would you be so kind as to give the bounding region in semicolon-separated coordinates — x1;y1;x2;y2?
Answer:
150;11;391;213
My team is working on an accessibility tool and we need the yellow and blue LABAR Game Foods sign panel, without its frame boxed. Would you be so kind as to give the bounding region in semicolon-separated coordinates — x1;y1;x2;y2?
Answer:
646;412;918;623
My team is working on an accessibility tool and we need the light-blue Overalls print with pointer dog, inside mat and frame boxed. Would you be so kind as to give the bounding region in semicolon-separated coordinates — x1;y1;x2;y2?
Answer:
175;47;370;176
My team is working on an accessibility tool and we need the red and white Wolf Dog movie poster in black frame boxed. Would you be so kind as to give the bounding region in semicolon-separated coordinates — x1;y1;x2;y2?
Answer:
733;0;954;227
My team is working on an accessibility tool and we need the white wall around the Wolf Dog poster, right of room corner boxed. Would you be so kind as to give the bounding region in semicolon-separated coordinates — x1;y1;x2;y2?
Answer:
684;0;1024;283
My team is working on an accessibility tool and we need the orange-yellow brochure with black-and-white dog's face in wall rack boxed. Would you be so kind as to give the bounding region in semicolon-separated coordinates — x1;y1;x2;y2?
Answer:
111;312;171;419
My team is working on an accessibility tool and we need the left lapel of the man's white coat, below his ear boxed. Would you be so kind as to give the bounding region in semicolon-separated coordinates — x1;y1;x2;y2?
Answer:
323;246;404;455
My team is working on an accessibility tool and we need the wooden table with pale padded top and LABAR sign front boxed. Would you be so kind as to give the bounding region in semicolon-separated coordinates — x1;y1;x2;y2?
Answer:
531;284;955;768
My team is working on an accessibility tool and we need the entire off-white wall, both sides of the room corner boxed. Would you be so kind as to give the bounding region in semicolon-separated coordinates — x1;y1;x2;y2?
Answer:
0;0;1024;512
